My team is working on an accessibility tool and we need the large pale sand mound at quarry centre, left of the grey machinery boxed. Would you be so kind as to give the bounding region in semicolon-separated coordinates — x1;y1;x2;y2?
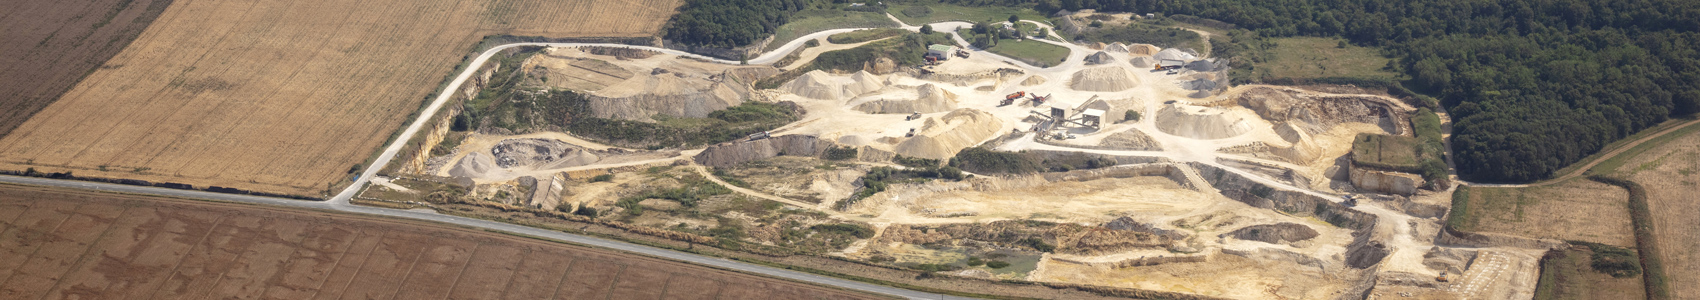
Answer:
896;109;1003;159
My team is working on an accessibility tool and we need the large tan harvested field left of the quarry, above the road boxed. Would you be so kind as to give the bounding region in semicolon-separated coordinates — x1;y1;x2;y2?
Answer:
0;0;678;196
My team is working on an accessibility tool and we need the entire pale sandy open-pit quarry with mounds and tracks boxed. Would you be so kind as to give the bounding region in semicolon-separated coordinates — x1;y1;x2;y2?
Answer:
354;22;1542;298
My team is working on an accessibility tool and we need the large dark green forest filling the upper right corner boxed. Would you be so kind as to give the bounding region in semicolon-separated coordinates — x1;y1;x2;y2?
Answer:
904;0;1700;182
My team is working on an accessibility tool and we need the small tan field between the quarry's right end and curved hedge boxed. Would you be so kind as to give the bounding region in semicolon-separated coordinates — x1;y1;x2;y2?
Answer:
1460;179;1635;247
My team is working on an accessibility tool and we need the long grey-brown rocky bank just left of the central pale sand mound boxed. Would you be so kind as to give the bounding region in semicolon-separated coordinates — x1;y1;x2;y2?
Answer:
692;135;833;167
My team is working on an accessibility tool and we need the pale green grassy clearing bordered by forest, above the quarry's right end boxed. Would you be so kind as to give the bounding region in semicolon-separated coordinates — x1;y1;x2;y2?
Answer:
1251;38;1399;78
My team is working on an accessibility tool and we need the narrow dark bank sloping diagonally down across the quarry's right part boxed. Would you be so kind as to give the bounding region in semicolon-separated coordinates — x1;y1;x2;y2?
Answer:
1188;162;1375;230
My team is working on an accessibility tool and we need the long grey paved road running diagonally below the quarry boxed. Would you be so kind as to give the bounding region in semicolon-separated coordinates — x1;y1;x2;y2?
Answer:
0;176;962;298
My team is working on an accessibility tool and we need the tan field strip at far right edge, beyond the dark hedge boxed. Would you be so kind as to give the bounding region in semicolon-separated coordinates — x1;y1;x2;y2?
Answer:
1617;133;1700;298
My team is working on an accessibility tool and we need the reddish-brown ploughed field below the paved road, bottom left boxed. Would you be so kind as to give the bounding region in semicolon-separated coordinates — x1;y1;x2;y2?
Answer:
0;186;876;298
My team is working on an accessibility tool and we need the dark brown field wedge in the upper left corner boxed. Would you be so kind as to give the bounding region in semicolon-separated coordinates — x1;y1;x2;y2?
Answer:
0;0;172;136
